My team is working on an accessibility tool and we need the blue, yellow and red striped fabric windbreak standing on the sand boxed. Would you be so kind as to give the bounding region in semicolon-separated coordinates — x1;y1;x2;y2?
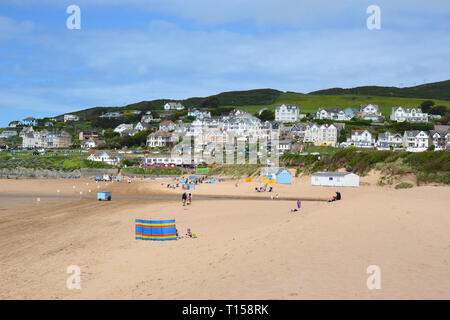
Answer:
136;219;177;241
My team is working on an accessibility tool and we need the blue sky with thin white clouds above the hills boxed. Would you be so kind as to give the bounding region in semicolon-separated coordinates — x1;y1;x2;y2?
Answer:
0;0;450;127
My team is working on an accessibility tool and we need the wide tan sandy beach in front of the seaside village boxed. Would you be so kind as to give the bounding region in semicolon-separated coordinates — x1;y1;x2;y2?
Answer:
0;177;450;299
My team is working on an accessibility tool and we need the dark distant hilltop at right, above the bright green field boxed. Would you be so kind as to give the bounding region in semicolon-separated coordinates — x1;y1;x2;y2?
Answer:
310;80;450;100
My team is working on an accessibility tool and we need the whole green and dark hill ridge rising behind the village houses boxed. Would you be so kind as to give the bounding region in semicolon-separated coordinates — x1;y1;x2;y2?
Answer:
57;80;450;121
